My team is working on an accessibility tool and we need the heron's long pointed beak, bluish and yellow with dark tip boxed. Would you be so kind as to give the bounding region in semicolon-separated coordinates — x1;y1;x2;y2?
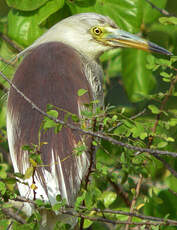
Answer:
104;29;173;56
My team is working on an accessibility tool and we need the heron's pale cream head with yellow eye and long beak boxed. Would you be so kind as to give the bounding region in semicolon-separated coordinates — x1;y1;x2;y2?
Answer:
28;13;172;59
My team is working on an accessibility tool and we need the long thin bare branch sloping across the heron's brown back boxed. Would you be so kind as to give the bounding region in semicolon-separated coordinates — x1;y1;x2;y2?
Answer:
0;71;177;157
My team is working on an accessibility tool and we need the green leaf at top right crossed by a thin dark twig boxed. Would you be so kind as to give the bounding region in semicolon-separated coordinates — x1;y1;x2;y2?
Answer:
142;0;167;24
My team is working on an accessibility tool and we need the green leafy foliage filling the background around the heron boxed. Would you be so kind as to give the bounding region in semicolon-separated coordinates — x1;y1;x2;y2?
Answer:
0;0;177;229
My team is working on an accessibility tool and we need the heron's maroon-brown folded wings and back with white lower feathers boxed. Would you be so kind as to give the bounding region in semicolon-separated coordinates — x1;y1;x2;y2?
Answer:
7;42;92;204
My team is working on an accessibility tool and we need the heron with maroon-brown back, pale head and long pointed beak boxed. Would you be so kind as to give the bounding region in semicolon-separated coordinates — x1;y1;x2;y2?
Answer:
7;13;172;229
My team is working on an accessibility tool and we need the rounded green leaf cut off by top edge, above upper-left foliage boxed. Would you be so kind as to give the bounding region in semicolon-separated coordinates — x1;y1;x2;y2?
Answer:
6;0;48;11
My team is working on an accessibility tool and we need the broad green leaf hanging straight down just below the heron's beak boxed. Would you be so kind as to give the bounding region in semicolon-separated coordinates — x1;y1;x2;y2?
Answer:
122;49;155;102
